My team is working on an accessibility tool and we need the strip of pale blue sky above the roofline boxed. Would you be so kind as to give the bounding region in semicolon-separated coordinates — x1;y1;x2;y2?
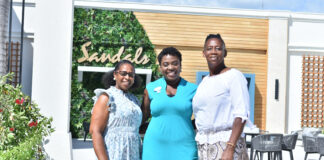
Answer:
104;0;324;14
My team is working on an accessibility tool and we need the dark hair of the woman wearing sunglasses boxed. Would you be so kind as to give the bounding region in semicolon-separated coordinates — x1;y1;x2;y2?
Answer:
101;60;142;89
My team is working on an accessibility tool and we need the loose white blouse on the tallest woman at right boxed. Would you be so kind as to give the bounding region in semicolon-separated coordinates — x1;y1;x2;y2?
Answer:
192;68;250;142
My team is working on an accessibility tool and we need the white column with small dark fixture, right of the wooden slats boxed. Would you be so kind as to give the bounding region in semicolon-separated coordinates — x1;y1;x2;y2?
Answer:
266;18;288;133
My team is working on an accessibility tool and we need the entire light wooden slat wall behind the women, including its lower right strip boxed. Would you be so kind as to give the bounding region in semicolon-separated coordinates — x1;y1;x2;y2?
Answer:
139;12;268;129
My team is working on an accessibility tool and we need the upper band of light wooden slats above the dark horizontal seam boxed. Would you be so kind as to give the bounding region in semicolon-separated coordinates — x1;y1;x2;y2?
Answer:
135;12;268;50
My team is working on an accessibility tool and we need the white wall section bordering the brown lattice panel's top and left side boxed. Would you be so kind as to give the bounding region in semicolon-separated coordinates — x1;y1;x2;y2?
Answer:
287;14;324;132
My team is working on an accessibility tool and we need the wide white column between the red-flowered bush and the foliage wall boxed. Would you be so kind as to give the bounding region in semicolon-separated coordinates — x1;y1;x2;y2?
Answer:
32;0;73;160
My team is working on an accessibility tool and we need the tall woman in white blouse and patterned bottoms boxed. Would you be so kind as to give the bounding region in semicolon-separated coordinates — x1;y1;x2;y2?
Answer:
192;34;250;160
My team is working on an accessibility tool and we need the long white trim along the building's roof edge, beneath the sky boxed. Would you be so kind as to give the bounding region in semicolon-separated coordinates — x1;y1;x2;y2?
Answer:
74;0;324;21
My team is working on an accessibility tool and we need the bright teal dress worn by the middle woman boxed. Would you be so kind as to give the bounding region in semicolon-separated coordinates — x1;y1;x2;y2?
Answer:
142;78;198;160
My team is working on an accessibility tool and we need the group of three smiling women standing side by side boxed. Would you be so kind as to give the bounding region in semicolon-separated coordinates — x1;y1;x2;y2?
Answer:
90;34;249;160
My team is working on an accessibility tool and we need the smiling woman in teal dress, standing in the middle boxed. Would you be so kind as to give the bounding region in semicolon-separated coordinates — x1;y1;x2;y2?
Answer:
142;47;198;160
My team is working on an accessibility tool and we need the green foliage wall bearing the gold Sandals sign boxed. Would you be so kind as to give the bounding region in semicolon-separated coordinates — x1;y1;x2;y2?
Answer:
70;8;158;137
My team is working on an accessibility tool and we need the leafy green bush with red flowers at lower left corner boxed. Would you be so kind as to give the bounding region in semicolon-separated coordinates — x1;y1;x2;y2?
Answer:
0;73;54;160
